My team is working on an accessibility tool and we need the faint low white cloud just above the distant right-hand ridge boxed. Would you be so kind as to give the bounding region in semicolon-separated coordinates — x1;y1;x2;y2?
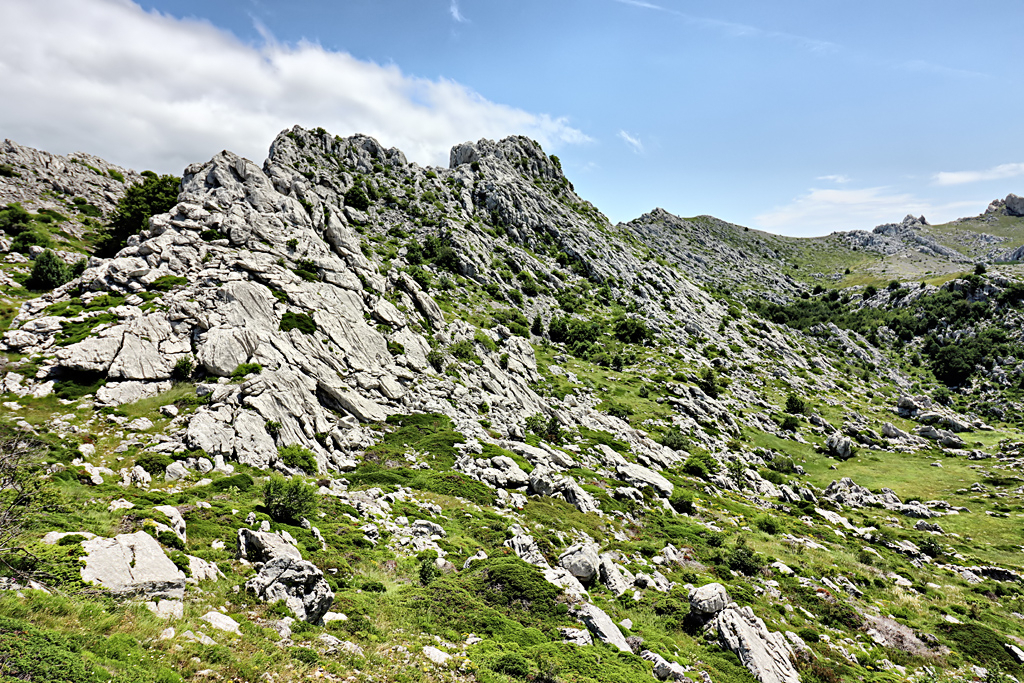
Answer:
755;187;985;237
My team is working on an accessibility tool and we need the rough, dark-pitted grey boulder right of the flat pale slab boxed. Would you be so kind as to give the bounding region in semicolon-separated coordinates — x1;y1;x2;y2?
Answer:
246;555;334;624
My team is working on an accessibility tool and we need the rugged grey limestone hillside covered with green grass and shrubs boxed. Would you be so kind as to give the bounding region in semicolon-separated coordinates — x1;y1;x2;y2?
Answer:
0;128;1024;683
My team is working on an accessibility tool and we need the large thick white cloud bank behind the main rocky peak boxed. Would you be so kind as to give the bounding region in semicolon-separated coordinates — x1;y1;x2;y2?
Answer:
0;0;590;172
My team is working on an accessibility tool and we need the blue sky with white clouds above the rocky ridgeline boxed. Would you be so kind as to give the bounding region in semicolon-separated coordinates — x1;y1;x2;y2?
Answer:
0;0;1024;237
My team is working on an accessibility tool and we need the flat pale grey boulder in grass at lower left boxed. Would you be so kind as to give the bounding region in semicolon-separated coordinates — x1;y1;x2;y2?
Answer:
73;531;185;600
